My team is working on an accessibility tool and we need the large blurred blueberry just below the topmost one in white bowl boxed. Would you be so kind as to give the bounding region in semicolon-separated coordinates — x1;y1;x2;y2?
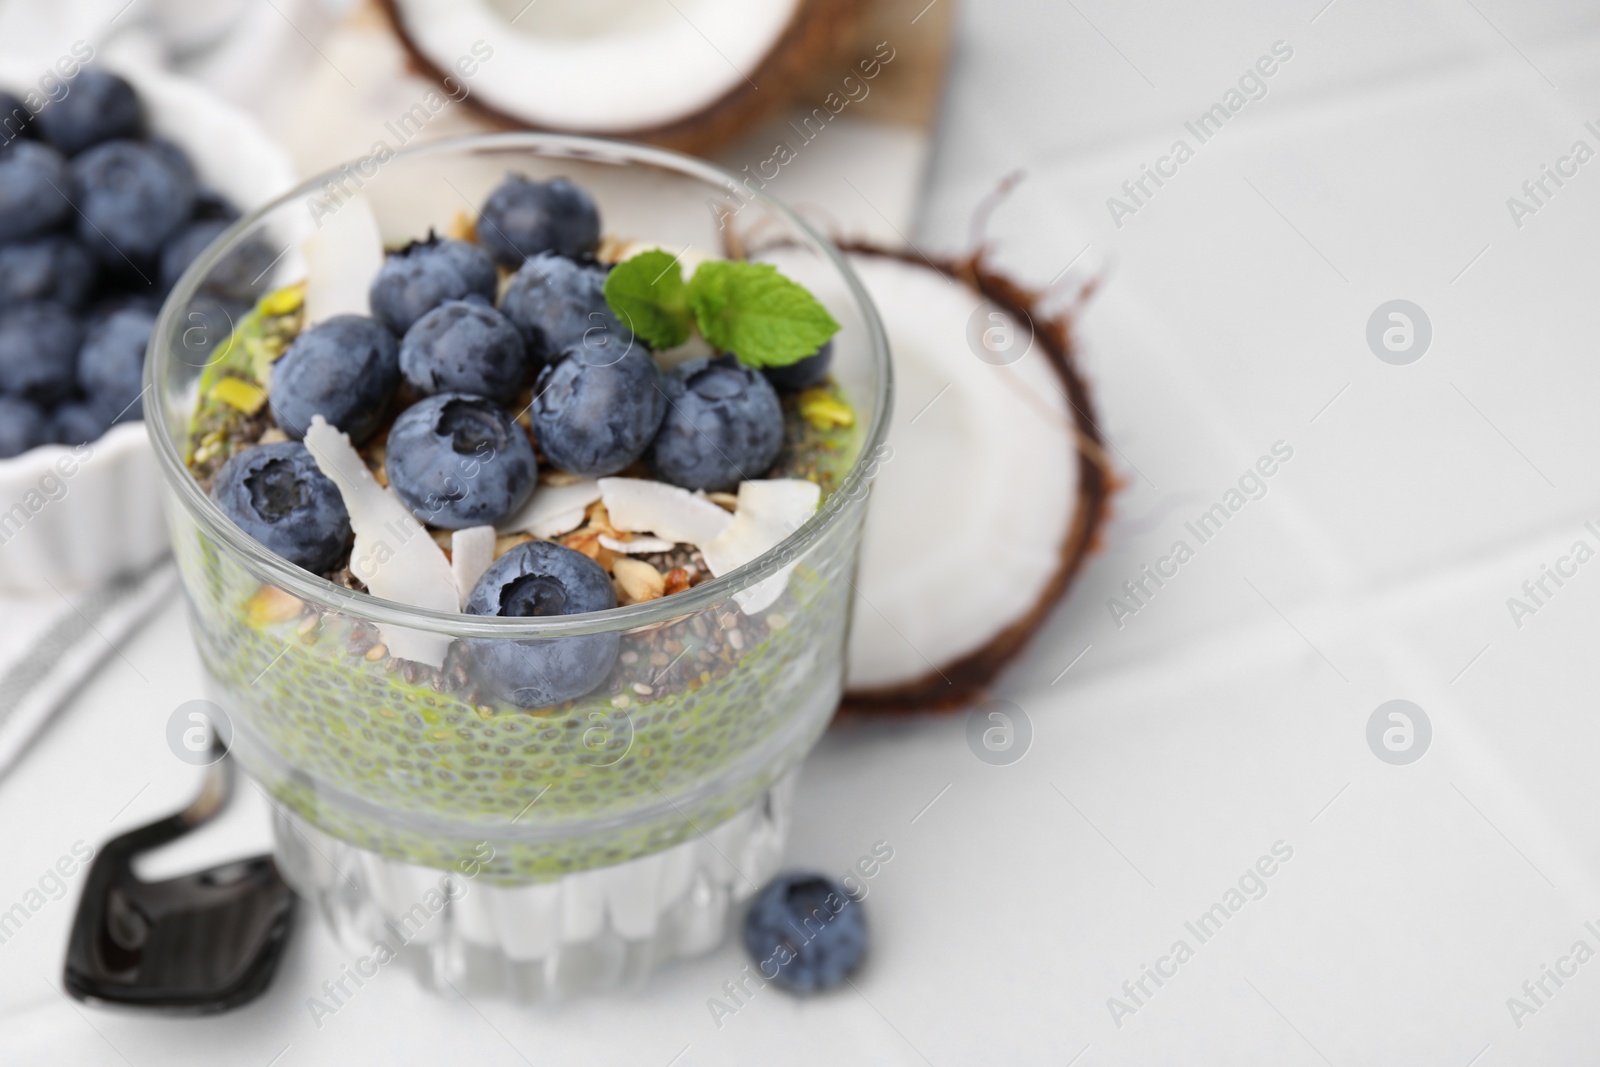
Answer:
72;139;195;272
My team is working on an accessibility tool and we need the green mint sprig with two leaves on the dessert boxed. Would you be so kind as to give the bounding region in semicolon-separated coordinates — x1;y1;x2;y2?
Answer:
605;251;838;366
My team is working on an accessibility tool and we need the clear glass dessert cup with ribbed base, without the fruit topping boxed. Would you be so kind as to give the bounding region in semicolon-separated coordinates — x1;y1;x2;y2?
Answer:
146;134;890;1000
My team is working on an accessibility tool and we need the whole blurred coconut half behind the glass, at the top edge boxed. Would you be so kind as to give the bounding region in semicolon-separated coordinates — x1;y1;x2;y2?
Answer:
382;0;859;154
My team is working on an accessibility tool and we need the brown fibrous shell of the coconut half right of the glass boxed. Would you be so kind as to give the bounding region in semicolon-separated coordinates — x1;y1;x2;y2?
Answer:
840;243;1117;715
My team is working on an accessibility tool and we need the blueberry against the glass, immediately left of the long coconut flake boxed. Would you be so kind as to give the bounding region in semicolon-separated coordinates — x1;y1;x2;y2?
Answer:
211;442;354;574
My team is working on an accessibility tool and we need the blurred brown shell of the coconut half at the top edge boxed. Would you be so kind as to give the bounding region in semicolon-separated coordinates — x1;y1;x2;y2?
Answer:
378;0;861;155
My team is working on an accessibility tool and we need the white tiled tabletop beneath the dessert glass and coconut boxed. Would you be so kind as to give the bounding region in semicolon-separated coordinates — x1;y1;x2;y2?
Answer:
9;0;1600;1067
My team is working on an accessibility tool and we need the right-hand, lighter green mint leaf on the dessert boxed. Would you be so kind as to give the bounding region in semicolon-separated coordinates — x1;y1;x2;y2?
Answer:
688;259;838;366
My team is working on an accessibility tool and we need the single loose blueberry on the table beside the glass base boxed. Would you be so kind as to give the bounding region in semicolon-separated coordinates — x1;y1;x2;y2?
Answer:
744;873;867;993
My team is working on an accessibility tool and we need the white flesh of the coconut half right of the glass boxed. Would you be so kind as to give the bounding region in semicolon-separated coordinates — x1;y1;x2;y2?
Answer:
846;254;1078;691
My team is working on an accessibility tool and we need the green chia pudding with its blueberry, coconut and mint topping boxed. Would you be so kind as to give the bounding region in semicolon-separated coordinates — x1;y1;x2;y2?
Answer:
150;134;888;991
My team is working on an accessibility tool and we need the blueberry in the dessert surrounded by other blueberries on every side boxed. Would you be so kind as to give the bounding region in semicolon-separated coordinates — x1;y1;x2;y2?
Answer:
400;301;528;403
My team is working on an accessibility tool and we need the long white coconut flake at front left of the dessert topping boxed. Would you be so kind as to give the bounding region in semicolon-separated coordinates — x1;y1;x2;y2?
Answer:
306;414;460;669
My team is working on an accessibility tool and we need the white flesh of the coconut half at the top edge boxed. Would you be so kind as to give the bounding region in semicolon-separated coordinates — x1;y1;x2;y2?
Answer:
394;0;802;133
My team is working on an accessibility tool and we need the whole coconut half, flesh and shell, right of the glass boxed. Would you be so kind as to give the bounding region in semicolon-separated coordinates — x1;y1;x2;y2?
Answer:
845;246;1112;712
